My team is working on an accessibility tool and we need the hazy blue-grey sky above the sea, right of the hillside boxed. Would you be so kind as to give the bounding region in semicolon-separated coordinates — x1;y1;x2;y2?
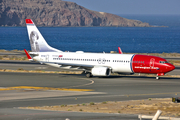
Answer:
64;0;180;15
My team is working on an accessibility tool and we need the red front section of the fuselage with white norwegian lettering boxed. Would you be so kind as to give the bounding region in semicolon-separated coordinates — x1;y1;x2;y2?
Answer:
132;55;175;74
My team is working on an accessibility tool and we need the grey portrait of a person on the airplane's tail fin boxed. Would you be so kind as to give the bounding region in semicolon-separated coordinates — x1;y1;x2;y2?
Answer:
30;31;40;52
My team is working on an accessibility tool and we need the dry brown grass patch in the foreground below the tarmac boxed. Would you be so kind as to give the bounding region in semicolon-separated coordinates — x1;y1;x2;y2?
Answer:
19;98;180;117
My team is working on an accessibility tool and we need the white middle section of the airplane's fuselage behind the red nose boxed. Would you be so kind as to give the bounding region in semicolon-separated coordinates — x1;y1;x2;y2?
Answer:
34;51;134;73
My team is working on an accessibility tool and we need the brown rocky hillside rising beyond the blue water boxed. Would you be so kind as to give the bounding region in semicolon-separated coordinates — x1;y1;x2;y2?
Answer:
0;0;151;27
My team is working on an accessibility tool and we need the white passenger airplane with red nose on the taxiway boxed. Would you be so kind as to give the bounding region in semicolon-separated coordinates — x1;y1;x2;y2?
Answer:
25;19;175;79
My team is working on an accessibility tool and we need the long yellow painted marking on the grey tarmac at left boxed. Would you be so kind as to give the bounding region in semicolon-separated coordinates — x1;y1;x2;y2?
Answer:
0;86;93;92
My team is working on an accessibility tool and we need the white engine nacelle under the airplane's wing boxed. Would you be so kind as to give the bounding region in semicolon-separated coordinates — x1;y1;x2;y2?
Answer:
91;67;111;76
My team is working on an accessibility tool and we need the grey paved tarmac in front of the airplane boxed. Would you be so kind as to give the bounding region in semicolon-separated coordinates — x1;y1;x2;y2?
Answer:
0;72;180;120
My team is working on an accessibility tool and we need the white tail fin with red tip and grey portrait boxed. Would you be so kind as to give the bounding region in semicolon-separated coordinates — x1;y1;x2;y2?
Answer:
26;19;62;52
